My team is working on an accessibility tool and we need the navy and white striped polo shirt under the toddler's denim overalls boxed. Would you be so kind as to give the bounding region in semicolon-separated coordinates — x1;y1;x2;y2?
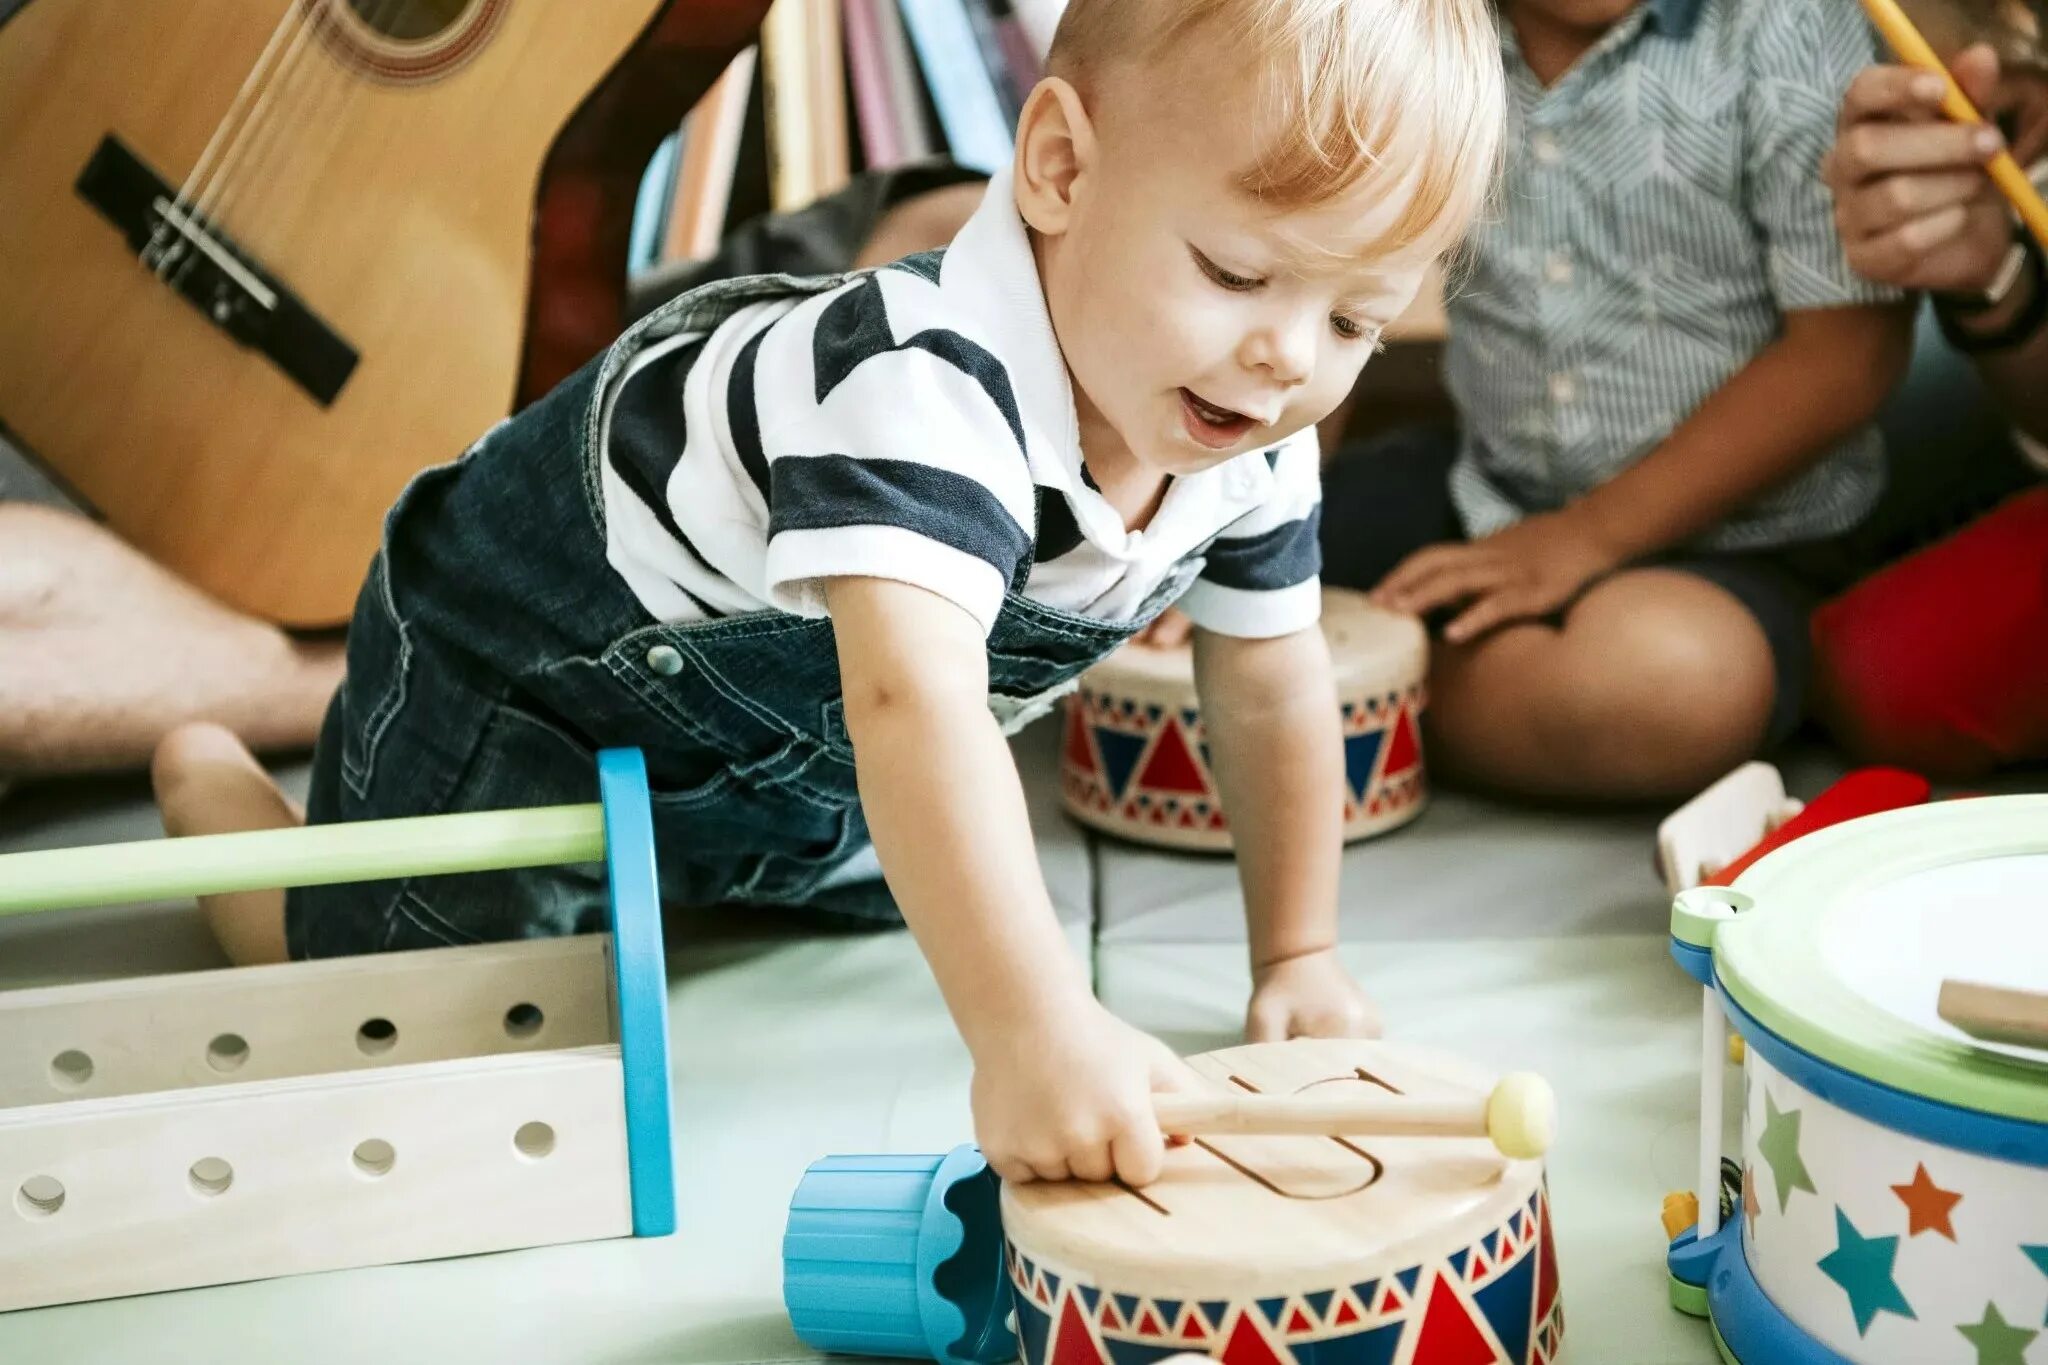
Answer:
602;162;1321;636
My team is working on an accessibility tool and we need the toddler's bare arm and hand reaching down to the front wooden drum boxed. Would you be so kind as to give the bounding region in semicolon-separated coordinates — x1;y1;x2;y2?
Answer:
823;577;1188;1185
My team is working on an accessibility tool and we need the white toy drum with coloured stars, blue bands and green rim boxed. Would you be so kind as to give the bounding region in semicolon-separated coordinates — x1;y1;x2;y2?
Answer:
1667;796;2048;1365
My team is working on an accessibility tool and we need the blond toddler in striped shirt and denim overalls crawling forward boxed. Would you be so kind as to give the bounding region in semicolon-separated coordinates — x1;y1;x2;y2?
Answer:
158;0;1501;1183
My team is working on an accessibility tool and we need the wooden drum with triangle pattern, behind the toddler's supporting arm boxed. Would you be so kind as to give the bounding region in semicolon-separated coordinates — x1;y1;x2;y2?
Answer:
1059;587;1430;851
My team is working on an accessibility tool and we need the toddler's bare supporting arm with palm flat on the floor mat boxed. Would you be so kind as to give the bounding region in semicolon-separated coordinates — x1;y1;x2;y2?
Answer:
1194;626;1378;1042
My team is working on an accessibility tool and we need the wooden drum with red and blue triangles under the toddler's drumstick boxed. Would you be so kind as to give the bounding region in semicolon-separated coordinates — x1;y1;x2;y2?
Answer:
1001;1042;1565;1365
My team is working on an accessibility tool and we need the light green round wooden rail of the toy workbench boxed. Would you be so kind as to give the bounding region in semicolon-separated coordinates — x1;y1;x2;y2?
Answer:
0;804;604;915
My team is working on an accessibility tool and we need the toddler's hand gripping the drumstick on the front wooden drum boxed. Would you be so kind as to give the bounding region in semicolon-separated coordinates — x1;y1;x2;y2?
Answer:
973;999;1202;1185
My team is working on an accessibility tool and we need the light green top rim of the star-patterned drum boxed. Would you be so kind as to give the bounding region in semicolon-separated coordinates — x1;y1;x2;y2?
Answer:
1714;796;2048;1124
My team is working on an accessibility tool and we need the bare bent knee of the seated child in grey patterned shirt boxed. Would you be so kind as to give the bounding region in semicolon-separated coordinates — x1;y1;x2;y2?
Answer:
1427;569;1778;800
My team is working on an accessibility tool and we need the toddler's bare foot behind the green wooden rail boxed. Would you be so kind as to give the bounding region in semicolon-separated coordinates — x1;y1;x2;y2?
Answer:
150;720;305;966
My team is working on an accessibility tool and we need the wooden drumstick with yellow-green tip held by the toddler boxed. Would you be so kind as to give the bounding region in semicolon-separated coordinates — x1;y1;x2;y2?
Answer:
1153;1072;1556;1160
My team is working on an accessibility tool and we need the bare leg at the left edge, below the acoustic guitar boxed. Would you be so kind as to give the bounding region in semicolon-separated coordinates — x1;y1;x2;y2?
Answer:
0;503;342;778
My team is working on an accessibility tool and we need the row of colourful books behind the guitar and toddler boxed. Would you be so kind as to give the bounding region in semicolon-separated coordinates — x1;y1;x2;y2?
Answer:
633;0;1065;270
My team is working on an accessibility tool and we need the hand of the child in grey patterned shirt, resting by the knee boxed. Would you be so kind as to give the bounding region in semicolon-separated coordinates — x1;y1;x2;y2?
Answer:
1372;512;1620;645
